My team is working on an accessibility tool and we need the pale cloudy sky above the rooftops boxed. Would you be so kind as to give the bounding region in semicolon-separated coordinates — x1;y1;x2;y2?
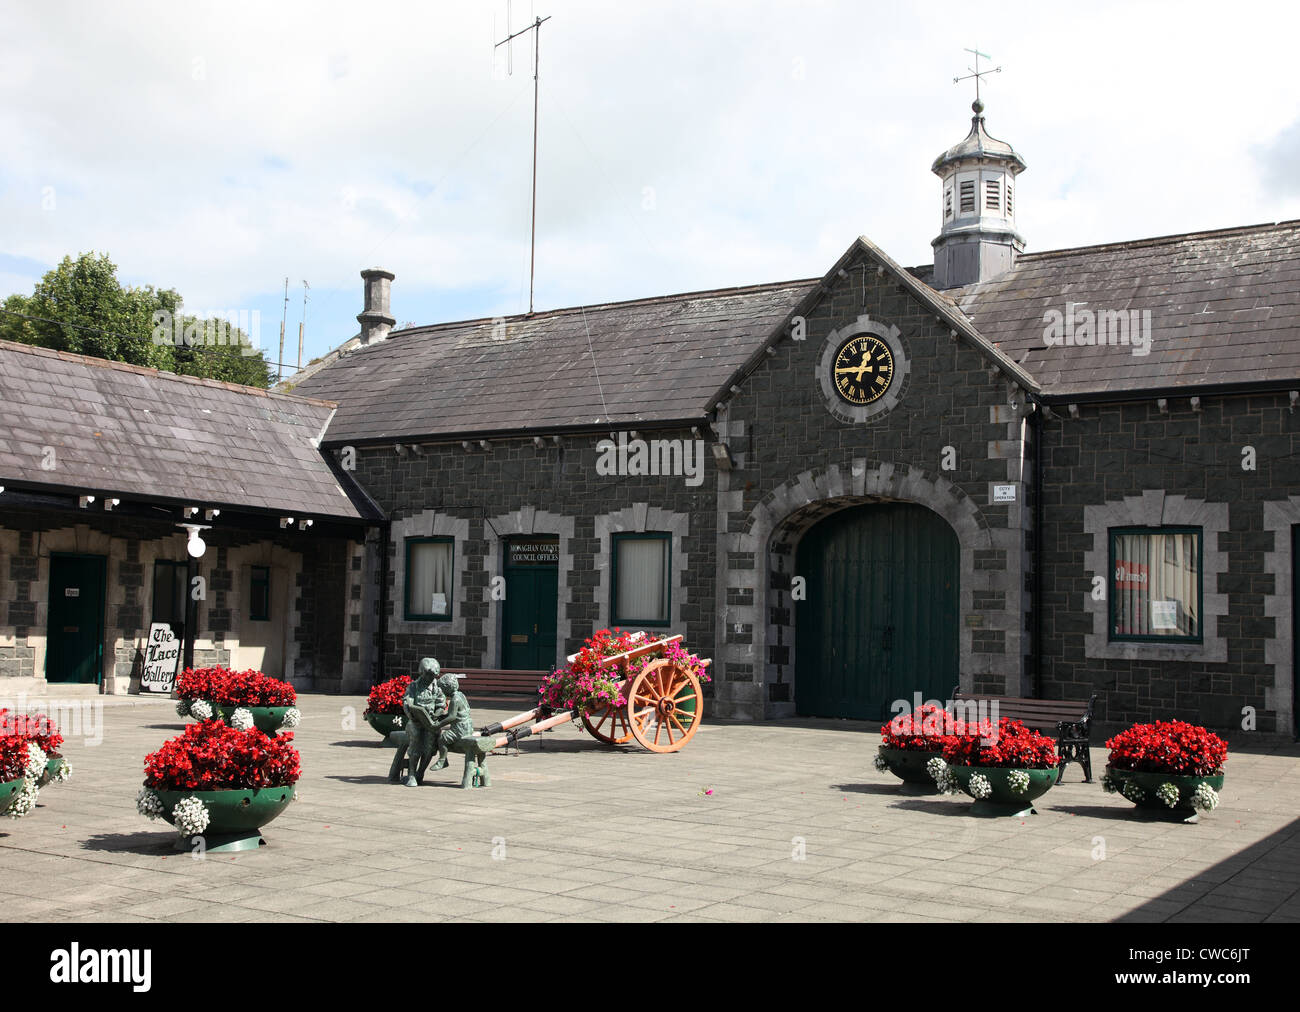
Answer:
0;0;1300;373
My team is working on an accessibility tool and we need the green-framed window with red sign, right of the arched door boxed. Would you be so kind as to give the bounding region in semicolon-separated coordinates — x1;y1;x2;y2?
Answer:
1110;527;1201;643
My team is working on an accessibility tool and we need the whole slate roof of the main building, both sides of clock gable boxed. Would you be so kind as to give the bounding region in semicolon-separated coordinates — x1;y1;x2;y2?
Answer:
293;221;1300;445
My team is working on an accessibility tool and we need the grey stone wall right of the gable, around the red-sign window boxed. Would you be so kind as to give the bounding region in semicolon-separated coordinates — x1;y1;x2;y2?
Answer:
1044;395;1300;732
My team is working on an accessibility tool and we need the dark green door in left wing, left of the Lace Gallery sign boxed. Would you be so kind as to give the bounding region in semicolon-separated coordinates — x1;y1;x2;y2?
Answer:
46;555;104;684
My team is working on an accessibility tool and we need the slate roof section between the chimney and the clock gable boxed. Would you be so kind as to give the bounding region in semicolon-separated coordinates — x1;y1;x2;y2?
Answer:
294;281;818;445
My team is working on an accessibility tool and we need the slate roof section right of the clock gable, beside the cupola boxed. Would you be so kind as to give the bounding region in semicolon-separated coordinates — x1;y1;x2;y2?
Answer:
944;221;1300;398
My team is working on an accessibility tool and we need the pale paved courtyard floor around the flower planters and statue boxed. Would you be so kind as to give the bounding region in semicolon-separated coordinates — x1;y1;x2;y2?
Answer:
0;696;1300;922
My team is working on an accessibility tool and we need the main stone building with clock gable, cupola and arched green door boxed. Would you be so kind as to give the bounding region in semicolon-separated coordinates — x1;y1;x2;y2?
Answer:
0;105;1300;735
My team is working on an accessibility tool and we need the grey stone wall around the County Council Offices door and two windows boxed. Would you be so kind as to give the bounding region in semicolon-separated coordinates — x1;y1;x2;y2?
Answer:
340;431;716;678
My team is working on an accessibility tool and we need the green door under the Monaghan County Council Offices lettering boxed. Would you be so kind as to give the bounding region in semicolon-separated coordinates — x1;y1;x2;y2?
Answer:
502;537;559;671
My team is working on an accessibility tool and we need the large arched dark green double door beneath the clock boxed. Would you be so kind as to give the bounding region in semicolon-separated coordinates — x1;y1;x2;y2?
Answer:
794;503;961;721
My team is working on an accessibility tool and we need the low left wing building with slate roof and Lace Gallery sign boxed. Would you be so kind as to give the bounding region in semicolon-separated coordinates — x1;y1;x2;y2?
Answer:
0;342;378;699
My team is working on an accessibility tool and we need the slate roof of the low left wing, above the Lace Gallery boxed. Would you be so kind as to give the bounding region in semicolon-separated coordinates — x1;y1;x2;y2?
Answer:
0;341;374;520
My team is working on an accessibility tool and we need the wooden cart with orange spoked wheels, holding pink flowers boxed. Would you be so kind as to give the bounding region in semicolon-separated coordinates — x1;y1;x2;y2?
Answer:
478;635;710;752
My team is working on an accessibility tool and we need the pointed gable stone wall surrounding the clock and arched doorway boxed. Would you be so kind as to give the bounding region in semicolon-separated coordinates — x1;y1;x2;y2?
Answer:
715;249;1031;719
